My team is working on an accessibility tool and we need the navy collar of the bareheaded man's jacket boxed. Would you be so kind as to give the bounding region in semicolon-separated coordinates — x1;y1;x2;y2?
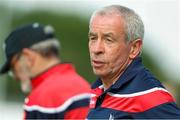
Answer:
91;57;144;91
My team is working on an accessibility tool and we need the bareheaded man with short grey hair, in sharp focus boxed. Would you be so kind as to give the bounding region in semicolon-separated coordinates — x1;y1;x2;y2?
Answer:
88;5;180;119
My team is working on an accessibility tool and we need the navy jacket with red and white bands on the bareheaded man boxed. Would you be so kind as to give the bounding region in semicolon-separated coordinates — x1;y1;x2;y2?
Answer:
87;57;180;119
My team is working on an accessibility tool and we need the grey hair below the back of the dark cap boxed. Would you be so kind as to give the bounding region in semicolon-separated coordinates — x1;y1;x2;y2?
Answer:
30;38;60;57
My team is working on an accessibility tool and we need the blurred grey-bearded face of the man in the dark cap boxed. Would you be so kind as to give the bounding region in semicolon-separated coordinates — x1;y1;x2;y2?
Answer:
11;54;31;93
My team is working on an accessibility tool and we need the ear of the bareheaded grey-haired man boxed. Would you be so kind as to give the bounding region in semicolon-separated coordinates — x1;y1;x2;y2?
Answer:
129;39;142;59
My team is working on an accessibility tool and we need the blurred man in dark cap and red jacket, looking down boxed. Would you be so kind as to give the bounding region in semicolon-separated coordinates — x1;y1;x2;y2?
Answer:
0;23;90;119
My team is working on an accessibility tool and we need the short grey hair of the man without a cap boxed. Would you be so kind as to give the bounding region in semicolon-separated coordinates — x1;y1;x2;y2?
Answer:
90;5;144;41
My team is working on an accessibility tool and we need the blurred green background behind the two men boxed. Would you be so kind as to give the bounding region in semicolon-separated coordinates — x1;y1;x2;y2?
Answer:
0;0;180;113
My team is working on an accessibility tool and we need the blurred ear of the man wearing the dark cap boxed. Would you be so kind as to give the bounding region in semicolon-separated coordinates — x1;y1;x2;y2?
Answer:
22;48;36;66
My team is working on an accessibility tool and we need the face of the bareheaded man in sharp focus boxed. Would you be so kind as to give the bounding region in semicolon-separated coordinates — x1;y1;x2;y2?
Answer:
89;15;130;77
